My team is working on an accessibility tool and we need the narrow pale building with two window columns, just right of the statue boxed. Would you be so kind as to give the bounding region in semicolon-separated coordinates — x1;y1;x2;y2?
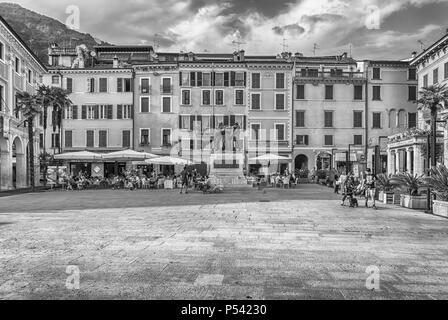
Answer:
246;53;294;172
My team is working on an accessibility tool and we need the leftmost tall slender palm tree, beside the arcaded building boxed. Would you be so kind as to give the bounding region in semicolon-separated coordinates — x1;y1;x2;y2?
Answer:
15;92;41;190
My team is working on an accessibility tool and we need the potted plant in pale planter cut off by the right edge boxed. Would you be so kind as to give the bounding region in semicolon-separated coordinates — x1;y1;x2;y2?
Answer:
424;165;448;218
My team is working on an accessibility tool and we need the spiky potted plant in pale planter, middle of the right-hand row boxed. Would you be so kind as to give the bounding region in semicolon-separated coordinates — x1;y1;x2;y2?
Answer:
391;172;427;210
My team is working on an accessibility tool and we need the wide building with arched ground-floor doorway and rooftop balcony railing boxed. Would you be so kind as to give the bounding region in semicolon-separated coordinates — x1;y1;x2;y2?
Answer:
293;54;366;174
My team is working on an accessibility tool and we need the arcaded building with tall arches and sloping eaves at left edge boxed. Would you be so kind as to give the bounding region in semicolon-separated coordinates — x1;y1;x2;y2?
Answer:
0;17;46;190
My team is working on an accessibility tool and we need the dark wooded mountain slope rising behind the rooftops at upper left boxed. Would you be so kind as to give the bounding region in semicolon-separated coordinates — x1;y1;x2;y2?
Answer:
0;2;109;64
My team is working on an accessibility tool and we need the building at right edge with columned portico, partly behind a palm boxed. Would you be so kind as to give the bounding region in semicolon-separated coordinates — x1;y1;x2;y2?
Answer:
387;33;448;174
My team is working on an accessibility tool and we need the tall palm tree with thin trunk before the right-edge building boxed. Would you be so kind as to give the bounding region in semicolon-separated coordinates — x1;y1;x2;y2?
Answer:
417;84;448;167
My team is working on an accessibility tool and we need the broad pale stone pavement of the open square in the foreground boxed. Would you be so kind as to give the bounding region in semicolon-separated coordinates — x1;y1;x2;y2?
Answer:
0;186;448;299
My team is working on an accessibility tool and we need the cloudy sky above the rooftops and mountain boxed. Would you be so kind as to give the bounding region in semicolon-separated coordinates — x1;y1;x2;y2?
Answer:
3;0;448;59
